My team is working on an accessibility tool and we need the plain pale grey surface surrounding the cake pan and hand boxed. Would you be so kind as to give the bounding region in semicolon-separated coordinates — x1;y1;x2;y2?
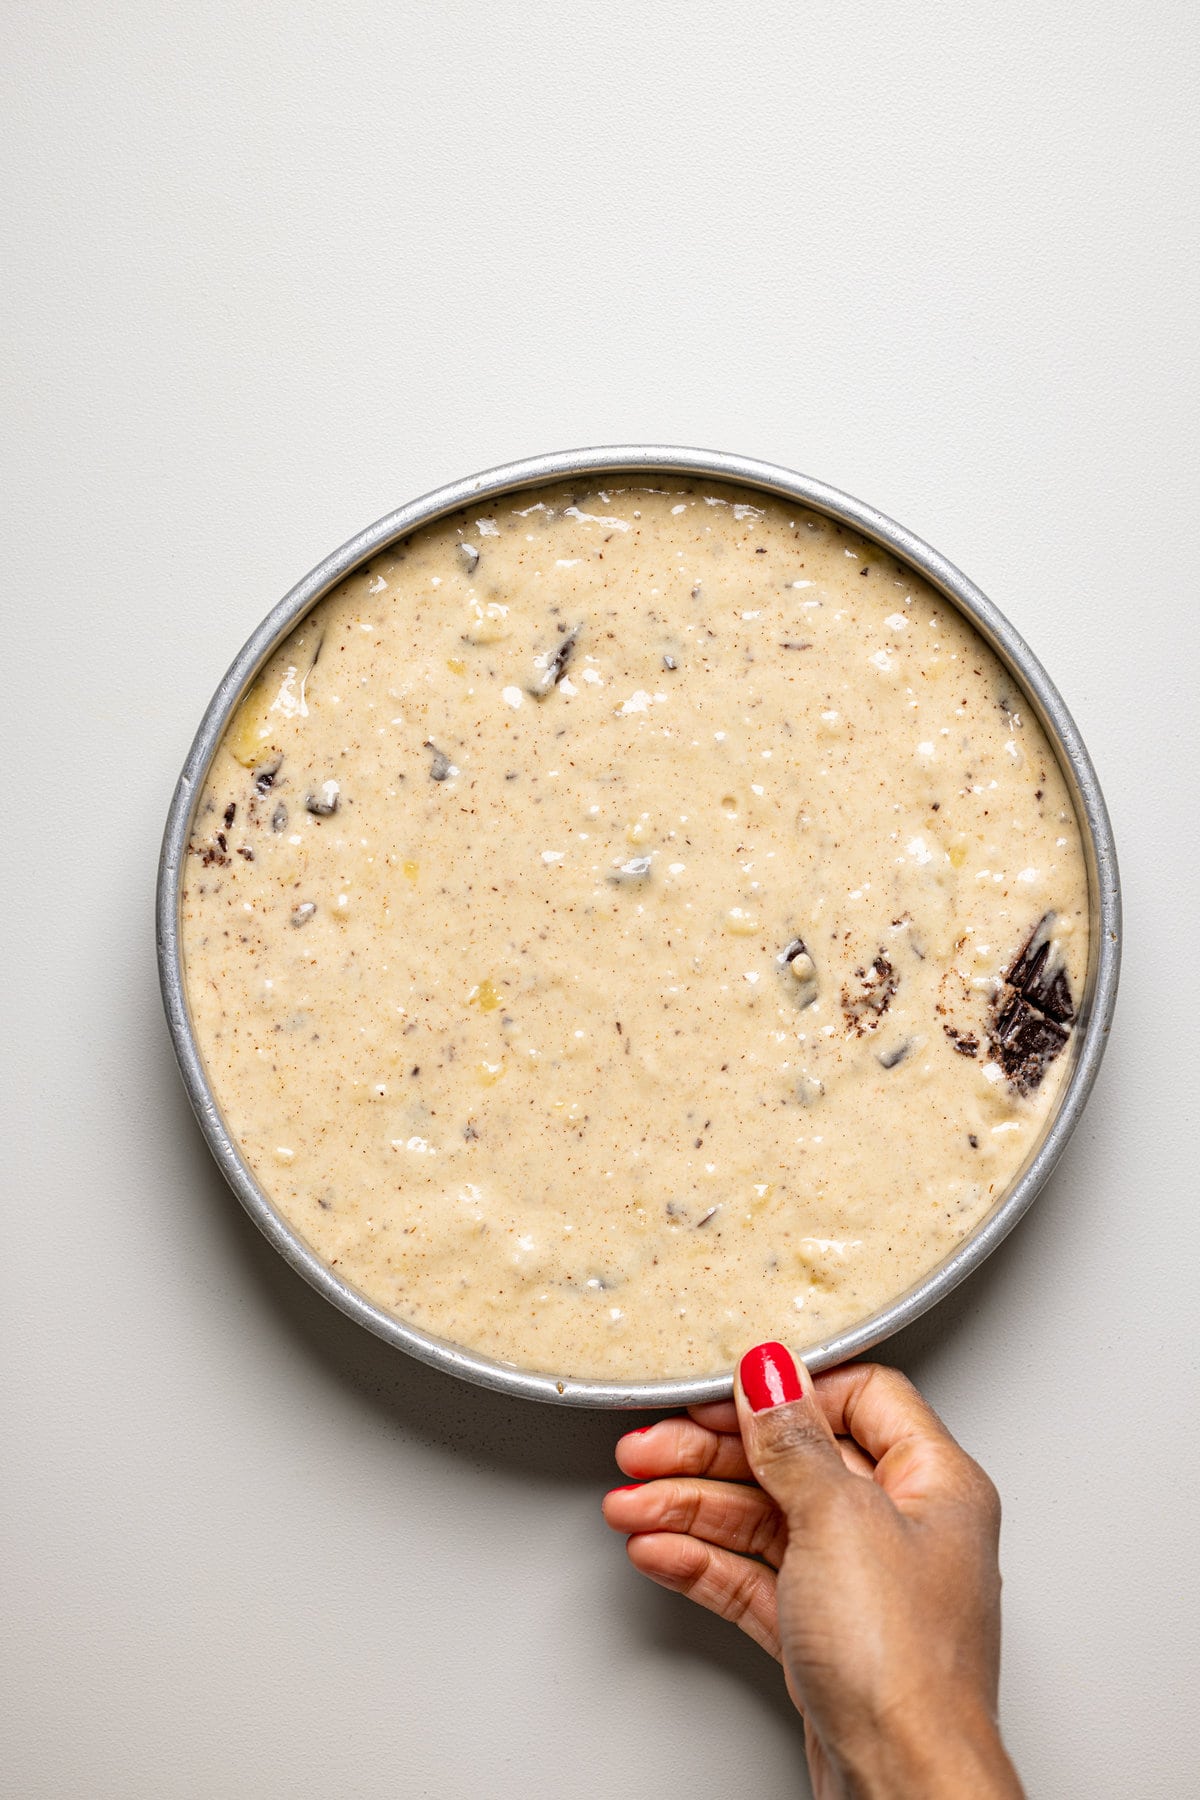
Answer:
0;0;1200;1800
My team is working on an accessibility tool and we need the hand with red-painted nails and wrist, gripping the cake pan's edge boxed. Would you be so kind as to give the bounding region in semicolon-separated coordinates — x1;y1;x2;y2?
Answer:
604;1345;1022;1800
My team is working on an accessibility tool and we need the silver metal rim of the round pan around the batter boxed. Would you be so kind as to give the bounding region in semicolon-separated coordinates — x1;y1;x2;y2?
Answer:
157;445;1121;1408
